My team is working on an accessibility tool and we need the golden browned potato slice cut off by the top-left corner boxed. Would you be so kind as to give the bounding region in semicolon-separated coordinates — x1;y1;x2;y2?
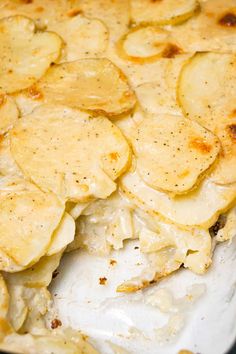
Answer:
0;0;71;29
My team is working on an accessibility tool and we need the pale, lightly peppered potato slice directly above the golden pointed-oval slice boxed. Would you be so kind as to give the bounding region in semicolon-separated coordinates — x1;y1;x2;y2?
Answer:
50;15;109;61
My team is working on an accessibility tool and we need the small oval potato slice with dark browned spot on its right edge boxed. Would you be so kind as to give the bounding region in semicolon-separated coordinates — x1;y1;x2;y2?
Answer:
117;26;181;64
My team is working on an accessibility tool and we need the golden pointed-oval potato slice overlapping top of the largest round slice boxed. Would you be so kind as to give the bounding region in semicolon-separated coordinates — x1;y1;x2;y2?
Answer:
30;58;136;116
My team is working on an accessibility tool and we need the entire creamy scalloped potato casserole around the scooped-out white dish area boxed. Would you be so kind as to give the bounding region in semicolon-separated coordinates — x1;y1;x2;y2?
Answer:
0;0;236;354
